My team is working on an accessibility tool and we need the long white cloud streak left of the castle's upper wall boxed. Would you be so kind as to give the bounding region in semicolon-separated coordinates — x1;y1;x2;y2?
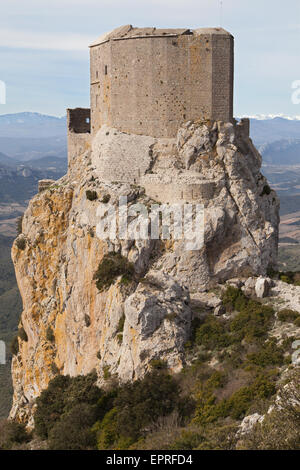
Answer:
0;28;95;51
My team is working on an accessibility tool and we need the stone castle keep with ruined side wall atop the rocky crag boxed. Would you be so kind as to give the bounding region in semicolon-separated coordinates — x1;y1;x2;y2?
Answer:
67;25;234;161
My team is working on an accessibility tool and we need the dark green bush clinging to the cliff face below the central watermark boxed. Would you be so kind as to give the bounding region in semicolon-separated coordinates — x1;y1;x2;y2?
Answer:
94;253;134;292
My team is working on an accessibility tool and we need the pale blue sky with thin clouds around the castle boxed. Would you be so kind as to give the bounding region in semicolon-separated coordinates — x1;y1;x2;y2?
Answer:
0;0;300;116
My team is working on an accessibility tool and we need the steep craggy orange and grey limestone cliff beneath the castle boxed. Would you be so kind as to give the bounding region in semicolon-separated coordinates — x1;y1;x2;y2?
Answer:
11;122;279;422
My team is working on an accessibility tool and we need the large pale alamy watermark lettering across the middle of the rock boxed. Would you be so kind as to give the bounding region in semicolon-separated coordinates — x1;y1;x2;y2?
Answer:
96;196;204;250
